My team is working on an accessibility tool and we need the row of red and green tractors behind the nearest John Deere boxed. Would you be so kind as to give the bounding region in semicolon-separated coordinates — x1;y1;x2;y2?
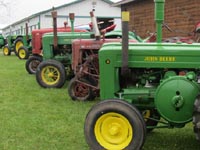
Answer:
0;11;139;100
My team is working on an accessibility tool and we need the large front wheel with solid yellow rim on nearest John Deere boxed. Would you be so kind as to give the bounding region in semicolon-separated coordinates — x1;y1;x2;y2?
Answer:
84;99;146;150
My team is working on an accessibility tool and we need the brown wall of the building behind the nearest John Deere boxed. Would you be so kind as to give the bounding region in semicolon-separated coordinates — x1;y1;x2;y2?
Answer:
122;0;200;38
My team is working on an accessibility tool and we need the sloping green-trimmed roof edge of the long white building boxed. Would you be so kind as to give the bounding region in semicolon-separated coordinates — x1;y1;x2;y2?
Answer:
2;0;114;29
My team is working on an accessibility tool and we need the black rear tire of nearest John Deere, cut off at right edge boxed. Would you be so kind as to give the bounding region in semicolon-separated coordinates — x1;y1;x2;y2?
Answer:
193;95;200;141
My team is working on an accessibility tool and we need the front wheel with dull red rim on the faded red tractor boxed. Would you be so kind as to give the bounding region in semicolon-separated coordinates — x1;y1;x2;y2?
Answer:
68;78;95;101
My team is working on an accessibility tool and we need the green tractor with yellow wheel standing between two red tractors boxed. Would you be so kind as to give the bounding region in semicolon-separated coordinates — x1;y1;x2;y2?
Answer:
36;11;93;88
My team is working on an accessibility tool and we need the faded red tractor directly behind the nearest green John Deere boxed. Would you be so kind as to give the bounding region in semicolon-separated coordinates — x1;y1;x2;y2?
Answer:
68;12;138;101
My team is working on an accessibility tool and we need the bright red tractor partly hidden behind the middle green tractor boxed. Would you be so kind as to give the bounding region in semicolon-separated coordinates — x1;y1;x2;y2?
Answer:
25;11;87;74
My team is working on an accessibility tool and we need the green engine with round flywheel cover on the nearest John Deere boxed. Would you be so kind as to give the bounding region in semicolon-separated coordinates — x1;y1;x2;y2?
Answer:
117;68;199;127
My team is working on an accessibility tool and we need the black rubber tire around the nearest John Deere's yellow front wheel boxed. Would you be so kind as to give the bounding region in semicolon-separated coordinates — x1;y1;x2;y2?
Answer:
84;99;146;150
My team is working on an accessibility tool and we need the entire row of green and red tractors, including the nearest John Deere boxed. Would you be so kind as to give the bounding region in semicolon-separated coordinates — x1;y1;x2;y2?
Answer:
0;0;200;150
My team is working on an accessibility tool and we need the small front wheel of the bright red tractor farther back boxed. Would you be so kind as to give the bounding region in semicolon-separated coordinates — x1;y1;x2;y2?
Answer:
25;56;42;74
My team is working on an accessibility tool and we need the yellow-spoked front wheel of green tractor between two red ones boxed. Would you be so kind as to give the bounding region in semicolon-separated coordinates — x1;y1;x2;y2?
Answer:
36;60;66;88
